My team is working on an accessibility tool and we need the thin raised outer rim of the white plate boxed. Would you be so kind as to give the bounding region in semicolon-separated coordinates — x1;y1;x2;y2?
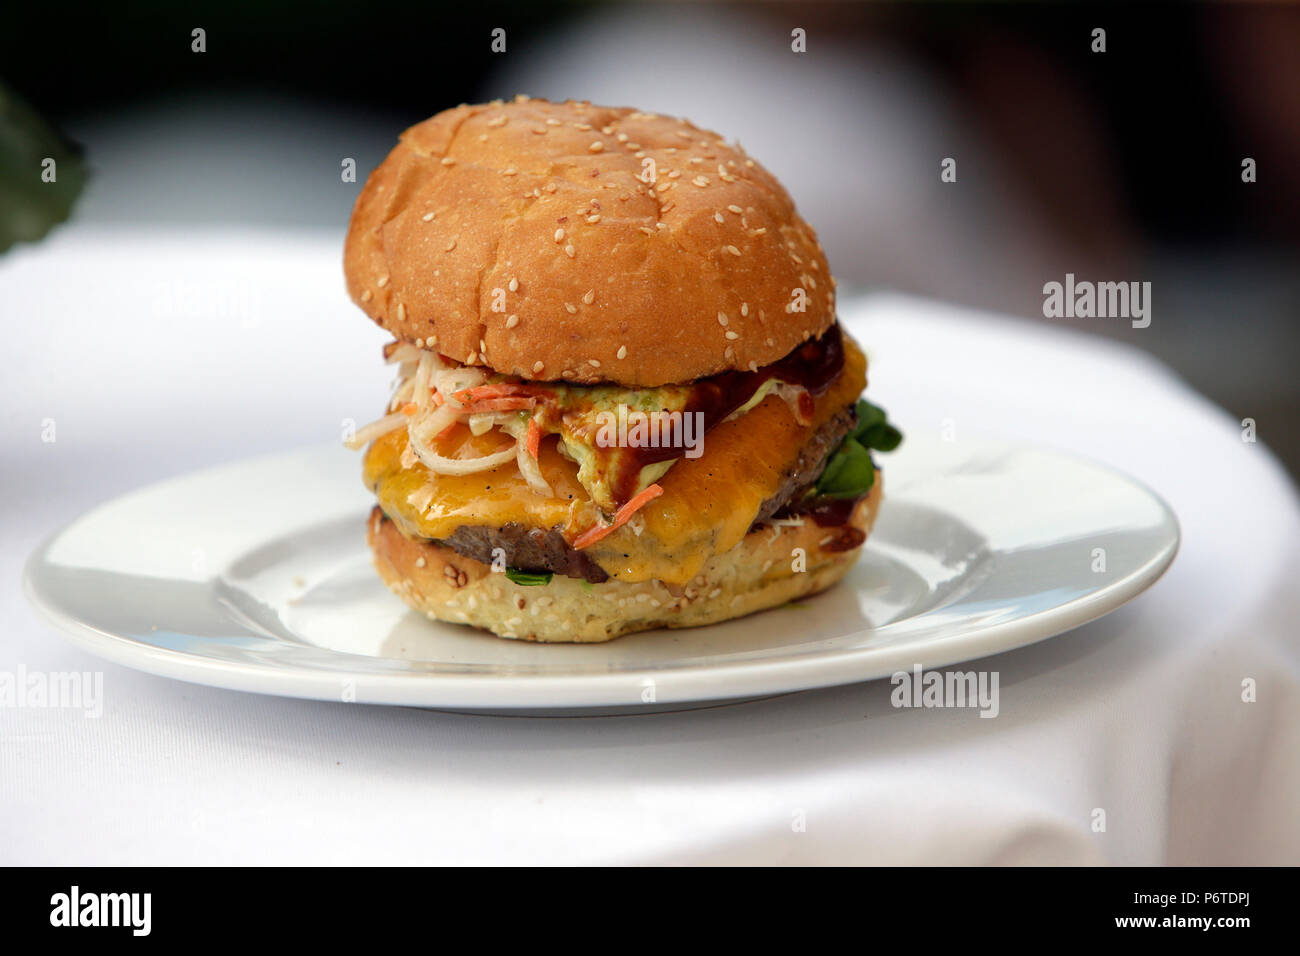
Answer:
22;438;1182;713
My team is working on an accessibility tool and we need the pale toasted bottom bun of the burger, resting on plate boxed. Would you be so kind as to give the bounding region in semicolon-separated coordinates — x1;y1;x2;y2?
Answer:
367;471;881;643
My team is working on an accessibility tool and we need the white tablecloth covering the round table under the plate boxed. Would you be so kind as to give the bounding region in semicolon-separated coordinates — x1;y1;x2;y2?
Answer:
0;228;1300;864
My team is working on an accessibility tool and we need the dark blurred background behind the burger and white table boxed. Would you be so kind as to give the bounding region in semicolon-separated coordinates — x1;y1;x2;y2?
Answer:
0;0;1300;473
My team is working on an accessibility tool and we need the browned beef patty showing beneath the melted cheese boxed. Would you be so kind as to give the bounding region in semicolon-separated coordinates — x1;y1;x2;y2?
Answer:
387;406;857;584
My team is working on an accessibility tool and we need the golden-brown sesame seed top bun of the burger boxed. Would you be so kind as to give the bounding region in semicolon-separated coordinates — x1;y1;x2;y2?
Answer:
343;96;835;386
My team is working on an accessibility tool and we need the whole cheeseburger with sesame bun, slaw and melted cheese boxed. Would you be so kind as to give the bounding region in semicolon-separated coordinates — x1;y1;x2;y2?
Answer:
345;96;900;641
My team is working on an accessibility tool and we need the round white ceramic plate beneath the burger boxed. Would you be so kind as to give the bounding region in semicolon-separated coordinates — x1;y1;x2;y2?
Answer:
26;436;1178;713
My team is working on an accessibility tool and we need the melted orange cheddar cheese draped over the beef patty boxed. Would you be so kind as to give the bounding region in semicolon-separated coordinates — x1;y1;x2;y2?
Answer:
364;336;866;585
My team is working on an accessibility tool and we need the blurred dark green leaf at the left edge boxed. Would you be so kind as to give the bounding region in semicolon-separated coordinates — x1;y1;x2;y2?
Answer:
0;86;86;252
